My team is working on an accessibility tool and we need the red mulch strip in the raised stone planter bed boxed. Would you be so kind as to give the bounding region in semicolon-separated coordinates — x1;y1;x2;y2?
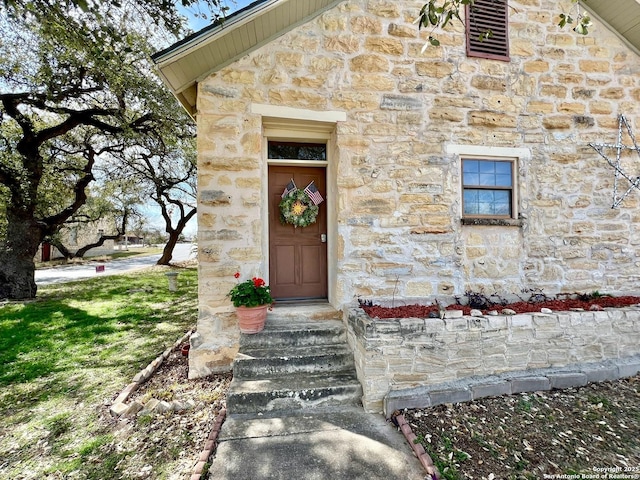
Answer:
360;295;640;318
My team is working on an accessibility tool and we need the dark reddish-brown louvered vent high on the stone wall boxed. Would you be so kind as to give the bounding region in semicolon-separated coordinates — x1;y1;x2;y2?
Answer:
466;0;509;61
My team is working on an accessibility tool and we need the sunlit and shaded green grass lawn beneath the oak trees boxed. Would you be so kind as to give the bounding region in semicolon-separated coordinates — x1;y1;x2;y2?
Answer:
0;268;197;479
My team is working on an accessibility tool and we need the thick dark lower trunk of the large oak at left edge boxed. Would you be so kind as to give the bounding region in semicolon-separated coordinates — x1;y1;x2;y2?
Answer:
0;208;44;300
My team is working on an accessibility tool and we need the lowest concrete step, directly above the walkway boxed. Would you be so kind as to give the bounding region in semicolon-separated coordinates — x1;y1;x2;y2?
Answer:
227;370;362;415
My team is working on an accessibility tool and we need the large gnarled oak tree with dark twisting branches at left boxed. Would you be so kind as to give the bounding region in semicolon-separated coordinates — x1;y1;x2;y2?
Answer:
0;0;208;299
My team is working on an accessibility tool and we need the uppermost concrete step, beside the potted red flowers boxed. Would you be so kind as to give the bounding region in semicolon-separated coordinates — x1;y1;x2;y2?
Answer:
240;314;347;350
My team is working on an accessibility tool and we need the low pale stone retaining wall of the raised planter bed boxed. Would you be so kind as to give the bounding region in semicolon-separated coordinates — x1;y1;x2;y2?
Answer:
347;308;640;411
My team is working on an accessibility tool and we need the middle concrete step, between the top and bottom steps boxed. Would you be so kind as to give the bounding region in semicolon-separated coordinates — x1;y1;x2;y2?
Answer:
233;342;354;379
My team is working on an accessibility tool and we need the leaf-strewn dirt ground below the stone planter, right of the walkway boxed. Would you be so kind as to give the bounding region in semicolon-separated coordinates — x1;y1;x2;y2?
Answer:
404;375;640;480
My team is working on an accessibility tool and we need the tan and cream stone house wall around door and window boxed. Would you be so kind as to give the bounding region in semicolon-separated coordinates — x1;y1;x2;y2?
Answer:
193;0;640;376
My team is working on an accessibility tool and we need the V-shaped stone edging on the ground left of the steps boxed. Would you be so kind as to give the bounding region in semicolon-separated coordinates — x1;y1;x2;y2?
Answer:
109;330;194;418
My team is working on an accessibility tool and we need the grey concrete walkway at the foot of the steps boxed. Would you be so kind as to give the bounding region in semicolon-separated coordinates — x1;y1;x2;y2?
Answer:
209;407;425;480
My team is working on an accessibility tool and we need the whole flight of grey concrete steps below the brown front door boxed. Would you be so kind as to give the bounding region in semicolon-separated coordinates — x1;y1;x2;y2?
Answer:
227;304;362;415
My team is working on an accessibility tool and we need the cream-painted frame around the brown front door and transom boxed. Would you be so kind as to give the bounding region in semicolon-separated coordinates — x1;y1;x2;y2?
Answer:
261;124;337;307
